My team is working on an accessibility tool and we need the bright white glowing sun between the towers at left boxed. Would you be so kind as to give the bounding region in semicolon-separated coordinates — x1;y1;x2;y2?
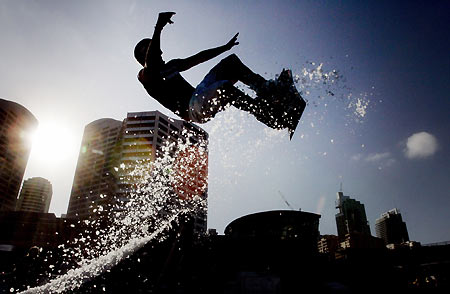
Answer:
30;122;79;165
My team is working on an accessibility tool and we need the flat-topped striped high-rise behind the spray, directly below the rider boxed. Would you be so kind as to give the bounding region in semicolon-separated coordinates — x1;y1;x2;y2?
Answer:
117;111;208;232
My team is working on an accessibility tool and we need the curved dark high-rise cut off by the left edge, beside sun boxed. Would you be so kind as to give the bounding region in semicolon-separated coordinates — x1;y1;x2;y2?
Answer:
0;99;38;211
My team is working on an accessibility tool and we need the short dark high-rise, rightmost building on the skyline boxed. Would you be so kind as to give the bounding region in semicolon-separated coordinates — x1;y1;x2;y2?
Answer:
375;208;409;244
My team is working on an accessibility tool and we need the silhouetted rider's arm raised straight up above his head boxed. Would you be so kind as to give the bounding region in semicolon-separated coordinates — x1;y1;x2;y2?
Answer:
145;12;175;68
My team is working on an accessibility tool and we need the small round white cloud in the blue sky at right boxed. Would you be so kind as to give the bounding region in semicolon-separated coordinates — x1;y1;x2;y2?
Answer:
405;132;439;159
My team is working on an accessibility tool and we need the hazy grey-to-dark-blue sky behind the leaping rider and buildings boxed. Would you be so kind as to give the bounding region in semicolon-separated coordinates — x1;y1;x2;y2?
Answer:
0;0;450;243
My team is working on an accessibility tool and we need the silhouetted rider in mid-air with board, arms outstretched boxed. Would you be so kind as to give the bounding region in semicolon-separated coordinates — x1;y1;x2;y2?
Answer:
134;12;304;135
